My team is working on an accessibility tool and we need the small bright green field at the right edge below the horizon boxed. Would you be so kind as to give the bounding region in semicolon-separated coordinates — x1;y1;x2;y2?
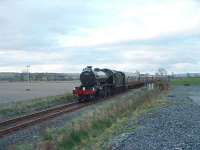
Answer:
171;77;200;85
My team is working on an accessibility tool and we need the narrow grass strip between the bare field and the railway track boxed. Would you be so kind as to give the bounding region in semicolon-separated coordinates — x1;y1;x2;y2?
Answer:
0;94;75;118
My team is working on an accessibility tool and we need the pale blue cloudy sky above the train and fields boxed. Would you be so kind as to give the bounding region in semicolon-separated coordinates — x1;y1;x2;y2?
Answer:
0;0;200;74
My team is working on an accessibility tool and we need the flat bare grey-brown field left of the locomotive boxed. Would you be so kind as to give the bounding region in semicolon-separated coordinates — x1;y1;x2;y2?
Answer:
0;81;80;103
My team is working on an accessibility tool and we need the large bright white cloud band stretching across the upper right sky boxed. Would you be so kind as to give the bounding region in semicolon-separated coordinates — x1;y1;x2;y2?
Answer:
57;1;200;47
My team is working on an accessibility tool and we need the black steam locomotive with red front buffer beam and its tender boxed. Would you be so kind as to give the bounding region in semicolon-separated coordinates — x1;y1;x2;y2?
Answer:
73;66;150;101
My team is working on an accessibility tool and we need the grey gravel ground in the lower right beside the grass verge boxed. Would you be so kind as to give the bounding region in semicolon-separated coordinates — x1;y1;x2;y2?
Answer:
113;86;200;150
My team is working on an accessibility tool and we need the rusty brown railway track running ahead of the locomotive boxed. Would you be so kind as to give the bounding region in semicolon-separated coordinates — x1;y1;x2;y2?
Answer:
0;102;91;137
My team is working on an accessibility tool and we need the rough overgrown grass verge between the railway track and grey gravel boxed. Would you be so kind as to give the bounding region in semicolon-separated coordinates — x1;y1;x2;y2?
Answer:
14;90;170;150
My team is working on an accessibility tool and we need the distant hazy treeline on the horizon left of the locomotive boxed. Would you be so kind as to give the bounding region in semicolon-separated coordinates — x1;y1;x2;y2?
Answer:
0;72;79;81
